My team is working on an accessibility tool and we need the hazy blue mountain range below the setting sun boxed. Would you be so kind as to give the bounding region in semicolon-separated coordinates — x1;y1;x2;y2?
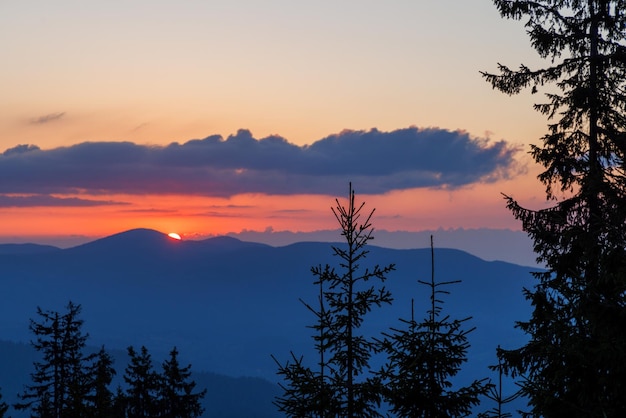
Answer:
0;229;532;416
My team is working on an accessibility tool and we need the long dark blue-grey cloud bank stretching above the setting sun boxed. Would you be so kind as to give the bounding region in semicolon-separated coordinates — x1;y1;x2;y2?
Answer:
0;128;519;197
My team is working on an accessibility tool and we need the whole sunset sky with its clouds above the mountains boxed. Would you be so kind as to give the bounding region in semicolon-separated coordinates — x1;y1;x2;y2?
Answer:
0;0;547;246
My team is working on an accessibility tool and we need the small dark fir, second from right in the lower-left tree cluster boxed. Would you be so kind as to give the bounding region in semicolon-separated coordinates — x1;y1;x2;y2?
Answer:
123;346;160;418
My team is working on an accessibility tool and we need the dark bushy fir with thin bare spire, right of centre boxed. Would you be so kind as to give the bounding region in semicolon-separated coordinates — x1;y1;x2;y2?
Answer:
380;236;490;418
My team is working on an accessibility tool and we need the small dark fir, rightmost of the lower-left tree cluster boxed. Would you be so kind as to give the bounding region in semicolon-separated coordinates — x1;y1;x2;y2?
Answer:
159;347;206;418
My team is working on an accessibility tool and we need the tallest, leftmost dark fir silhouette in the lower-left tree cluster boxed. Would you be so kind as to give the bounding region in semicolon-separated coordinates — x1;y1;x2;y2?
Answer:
14;302;93;418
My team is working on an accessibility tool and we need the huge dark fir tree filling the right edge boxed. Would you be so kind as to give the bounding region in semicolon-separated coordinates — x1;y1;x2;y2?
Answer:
483;0;626;417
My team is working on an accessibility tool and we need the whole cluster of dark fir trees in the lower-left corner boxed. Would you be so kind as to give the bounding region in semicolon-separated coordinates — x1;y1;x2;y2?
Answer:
0;301;206;418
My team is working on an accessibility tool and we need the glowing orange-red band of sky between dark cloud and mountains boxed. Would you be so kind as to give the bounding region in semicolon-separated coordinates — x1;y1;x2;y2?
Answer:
0;168;545;247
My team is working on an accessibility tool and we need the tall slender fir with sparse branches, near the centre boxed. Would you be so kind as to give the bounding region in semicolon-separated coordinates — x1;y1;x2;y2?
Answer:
275;184;394;418
